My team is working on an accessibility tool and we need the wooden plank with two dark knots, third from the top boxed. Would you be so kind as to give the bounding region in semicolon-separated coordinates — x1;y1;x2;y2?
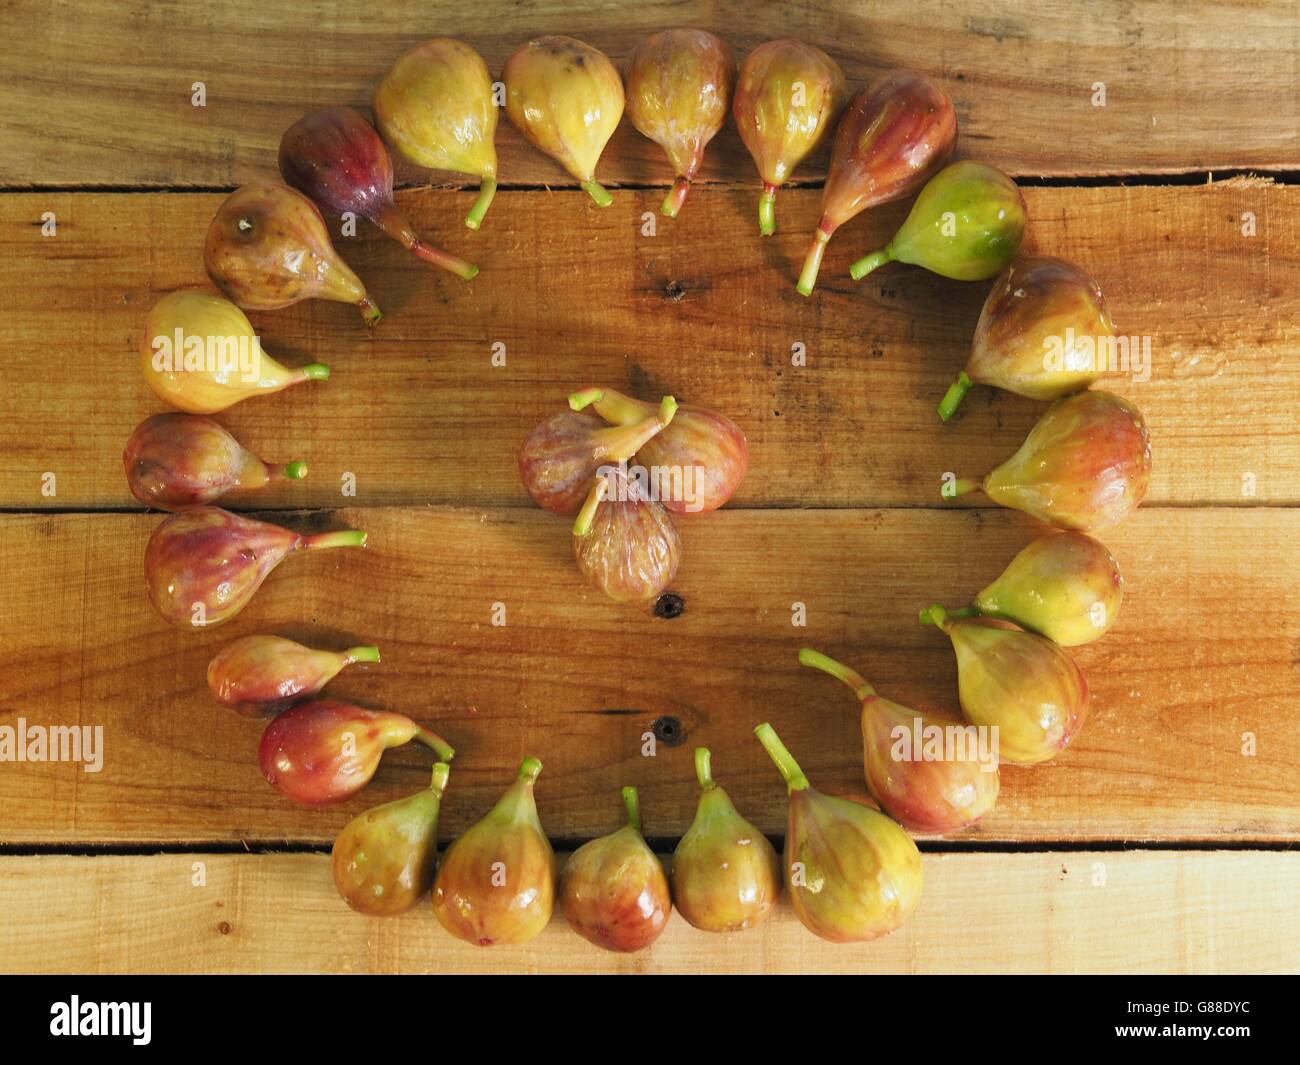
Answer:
0;508;1300;845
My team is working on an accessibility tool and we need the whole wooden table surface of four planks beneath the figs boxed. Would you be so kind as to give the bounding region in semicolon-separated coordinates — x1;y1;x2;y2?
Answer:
0;0;1300;973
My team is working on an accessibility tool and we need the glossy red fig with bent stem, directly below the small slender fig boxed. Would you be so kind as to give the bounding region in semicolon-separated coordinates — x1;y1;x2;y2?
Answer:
257;700;455;806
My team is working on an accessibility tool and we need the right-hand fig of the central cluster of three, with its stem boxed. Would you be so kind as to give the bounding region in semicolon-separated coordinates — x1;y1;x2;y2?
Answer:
569;389;749;514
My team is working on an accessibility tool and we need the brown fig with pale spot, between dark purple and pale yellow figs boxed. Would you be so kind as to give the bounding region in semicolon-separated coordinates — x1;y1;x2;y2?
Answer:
203;181;382;325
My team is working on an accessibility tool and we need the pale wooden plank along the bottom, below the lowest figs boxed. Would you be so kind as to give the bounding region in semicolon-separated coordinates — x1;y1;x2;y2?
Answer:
0;852;1300;974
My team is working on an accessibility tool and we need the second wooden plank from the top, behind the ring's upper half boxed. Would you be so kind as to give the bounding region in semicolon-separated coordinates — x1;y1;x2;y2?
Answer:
0;182;1300;510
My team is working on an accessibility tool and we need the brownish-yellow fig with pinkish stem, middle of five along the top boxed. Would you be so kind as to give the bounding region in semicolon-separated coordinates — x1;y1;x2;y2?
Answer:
628;30;736;218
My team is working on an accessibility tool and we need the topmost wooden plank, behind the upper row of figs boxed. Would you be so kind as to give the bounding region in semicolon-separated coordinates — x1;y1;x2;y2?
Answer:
0;0;1300;185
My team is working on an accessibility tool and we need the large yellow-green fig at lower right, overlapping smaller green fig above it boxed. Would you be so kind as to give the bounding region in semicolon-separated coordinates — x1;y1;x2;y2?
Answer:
920;603;1088;766
